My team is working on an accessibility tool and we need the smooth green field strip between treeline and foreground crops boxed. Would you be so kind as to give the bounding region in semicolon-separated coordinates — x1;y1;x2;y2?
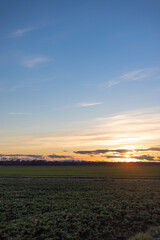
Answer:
0;164;160;178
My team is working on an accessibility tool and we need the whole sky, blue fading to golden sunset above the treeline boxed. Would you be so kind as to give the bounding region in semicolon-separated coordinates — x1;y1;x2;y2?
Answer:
0;0;160;161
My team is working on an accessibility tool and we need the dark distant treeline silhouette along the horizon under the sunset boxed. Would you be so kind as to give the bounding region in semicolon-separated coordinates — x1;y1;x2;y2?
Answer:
0;160;160;167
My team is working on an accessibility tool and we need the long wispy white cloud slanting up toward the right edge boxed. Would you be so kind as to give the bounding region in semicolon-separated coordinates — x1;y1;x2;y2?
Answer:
107;69;154;87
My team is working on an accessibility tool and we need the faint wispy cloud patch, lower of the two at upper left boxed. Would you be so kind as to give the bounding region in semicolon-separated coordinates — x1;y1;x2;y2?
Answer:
22;57;49;68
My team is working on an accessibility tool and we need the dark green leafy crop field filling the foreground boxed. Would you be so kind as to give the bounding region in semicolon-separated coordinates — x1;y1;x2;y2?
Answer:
0;179;160;240
